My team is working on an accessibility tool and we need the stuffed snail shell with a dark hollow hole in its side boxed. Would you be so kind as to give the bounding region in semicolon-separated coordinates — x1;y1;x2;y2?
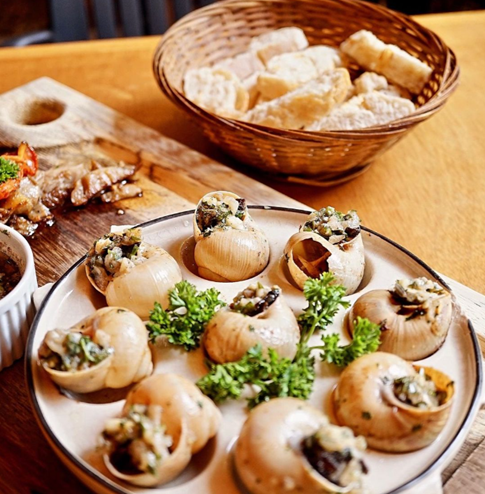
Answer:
284;206;365;295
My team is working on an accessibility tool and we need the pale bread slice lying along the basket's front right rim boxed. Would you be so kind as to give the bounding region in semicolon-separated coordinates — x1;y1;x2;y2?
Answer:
305;91;415;131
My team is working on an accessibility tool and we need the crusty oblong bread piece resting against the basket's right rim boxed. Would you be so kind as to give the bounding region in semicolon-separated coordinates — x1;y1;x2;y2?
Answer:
340;30;433;94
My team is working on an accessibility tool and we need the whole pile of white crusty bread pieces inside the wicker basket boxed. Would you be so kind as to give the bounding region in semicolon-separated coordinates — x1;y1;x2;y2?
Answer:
184;27;432;132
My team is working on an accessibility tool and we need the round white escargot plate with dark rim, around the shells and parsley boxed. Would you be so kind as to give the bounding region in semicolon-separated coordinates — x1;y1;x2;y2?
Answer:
26;206;482;494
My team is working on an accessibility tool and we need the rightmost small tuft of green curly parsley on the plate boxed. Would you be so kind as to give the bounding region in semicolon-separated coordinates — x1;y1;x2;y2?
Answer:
318;317;381;367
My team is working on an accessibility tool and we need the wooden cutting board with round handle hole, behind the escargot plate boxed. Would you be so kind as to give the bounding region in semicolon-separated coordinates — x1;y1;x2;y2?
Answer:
0;77;302;285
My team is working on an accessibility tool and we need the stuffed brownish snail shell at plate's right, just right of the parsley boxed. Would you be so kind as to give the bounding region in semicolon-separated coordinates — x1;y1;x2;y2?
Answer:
349;277;453;360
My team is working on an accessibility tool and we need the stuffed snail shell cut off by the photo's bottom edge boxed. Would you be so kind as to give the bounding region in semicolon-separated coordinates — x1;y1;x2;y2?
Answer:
234;398;367;494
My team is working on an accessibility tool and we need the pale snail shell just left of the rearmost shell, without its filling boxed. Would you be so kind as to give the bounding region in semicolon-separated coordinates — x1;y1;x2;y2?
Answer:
85;234;182;319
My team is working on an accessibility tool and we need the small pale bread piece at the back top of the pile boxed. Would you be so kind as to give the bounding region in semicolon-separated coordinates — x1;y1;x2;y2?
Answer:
249;27;308;65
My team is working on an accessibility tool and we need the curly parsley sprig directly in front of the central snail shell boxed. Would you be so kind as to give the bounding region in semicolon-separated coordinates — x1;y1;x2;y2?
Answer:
197;345;315;408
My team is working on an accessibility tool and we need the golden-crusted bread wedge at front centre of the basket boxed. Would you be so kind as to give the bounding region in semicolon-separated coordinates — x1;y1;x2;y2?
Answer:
244;69;351;129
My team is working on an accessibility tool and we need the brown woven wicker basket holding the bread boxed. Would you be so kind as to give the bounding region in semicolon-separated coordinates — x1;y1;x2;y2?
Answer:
154;0;459;185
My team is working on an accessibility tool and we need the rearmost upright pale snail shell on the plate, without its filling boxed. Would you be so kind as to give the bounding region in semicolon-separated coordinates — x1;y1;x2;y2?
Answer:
194;191;270;282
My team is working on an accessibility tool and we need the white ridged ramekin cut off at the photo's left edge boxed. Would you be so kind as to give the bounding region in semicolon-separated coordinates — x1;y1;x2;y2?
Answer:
0;223;37;371
